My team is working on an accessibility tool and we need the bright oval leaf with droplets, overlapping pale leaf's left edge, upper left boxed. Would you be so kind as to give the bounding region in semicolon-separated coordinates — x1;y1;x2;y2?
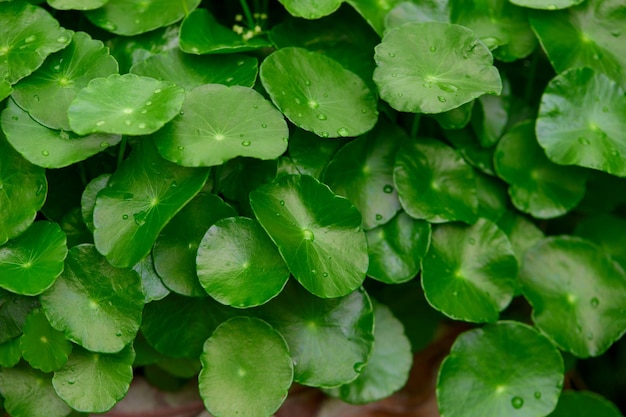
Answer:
68;74;185;135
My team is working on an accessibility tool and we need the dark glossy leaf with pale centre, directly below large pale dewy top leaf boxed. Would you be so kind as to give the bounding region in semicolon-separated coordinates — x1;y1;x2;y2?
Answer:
393;139;478;223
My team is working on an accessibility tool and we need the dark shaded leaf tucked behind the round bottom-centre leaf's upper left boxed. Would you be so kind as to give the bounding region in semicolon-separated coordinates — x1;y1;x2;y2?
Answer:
141;294;232;358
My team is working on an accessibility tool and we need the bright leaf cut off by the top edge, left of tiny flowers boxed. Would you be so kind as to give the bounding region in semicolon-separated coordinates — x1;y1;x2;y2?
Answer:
85;0;200;36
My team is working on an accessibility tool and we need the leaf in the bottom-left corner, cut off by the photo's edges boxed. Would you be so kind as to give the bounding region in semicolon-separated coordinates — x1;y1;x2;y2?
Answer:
0;363;72;417
